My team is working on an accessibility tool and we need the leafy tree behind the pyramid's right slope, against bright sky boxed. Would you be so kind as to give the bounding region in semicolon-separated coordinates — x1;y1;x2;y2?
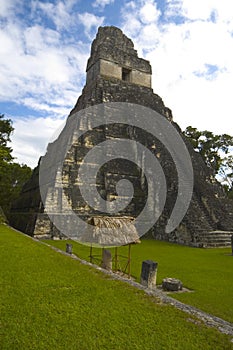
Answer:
184;126;233;192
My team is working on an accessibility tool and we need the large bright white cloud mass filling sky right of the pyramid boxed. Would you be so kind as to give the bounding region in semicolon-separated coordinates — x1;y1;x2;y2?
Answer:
122;0;233;133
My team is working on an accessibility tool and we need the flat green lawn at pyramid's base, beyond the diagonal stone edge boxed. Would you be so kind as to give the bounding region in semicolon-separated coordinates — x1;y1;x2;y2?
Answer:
47;240;233;322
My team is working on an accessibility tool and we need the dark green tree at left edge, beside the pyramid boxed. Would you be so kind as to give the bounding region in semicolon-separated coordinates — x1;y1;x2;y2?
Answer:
0;114;31;216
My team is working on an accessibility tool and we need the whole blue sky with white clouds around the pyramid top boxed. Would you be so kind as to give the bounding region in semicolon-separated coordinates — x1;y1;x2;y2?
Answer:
0;0;233;167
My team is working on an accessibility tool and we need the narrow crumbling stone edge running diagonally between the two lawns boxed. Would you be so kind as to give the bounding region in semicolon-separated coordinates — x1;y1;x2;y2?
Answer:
15;230;233;342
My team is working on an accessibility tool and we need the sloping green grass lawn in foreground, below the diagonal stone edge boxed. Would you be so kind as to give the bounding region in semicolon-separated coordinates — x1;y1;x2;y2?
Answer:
0;226;233;350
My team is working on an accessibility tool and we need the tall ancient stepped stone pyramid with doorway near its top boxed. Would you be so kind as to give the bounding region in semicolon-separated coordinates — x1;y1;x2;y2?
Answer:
10;27;233;246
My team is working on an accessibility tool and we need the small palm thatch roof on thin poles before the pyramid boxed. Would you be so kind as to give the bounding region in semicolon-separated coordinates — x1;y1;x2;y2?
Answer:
82;216;140;246
